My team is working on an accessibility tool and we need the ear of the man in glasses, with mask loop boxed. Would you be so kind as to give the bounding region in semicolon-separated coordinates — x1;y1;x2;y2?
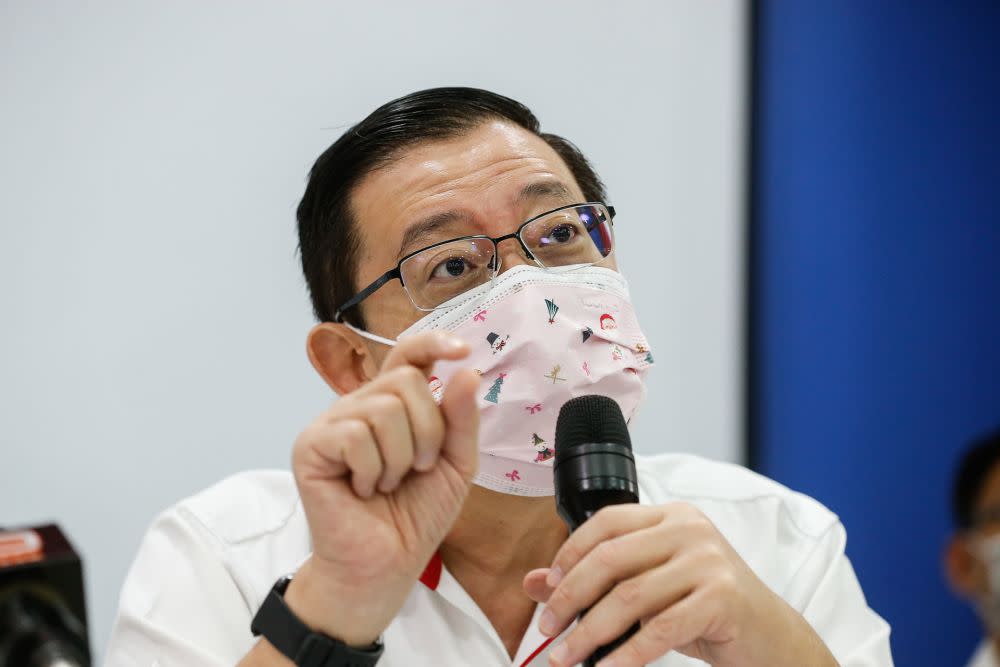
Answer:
306;322;378;396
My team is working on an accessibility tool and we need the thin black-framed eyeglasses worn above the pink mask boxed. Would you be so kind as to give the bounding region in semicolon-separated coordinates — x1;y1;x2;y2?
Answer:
333;202;615;322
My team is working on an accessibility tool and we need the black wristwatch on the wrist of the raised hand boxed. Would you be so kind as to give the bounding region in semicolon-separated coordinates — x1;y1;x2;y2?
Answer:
250;575;384;667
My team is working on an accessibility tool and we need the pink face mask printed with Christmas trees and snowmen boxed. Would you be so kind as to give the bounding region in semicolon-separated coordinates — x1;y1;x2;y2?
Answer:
352;265;653;496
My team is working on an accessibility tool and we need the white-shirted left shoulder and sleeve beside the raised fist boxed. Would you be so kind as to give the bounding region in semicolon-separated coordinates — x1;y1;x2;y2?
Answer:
107;470;310;665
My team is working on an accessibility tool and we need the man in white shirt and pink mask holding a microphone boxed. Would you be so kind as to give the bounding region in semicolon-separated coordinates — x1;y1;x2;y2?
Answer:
109;88;892;667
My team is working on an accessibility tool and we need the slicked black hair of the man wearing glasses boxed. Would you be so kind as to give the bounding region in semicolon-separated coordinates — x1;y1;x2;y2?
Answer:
296;88;606;327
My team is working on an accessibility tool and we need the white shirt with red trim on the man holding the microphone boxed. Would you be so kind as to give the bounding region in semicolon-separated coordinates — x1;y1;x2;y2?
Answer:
107;454;892;667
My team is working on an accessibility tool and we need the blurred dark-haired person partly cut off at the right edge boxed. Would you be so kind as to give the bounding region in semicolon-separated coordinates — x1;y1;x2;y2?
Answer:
944;430;1000;667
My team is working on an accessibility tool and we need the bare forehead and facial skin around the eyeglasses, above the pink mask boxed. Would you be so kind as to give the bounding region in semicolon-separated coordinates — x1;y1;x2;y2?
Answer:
351;121;614;363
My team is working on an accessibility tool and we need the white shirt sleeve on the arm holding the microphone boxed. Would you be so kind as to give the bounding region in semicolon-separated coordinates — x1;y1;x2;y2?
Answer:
783;521;892;667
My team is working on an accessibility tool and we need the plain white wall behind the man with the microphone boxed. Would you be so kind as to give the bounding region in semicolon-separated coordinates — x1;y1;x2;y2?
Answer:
0;0;745;656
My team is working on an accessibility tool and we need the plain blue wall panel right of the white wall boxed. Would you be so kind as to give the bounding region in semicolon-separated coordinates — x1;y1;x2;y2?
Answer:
749;0;1000;667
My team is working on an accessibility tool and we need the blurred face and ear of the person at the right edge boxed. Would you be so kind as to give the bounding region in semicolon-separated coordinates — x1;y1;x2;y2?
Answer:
946;464;1000;600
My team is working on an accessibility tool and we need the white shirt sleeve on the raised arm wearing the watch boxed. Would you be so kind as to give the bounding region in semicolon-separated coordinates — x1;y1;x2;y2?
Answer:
105;506;254;667
